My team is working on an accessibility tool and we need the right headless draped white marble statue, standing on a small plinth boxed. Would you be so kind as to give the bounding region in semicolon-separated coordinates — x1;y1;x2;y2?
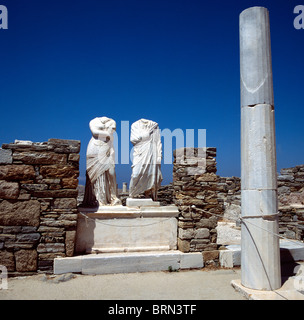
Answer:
129;119;162;200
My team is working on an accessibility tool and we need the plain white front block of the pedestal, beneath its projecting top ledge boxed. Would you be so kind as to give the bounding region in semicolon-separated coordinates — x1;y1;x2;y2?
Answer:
75;214;177;253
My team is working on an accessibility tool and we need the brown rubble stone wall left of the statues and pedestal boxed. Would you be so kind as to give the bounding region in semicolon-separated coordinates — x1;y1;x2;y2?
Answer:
0;139;80;274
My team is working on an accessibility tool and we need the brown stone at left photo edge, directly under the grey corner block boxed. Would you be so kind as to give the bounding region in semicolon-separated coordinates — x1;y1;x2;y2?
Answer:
0;164;35;181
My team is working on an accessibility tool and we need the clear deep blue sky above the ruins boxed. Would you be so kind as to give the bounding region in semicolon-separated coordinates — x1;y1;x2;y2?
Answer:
0;0;304;187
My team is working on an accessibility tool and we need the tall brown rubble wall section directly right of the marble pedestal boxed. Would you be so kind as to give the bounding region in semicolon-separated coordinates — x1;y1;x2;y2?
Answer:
173;148;223;263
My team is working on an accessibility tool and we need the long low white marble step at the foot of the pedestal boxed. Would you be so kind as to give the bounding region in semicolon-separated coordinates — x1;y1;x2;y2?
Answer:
54;250;204;274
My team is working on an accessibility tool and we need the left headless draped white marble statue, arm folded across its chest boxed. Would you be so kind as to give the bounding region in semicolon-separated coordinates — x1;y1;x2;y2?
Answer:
83;117;121;206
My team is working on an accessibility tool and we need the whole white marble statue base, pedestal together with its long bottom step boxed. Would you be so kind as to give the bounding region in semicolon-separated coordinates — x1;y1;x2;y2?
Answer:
54;204;204;274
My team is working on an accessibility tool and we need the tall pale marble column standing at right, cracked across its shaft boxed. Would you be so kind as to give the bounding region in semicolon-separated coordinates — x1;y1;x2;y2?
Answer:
240;7;281;290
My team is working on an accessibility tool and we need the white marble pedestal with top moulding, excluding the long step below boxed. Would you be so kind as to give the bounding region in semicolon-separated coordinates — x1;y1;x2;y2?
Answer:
75;205;178;254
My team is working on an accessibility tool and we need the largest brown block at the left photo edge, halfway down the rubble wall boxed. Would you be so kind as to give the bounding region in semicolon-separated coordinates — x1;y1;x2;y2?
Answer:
0;200;40;226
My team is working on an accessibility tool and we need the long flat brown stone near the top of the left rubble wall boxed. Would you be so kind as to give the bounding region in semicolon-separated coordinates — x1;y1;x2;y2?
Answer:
13;151;67;164
